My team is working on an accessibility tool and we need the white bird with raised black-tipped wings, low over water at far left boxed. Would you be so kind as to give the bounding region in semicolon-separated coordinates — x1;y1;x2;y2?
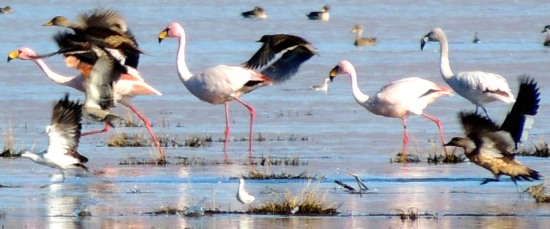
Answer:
21;94;88;180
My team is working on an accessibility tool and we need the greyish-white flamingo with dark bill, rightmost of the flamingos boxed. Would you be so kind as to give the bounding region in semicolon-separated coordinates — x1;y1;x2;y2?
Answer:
420;28;516;116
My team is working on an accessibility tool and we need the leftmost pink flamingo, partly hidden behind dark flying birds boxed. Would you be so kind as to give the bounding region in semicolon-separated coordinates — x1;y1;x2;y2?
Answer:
8;47;165;160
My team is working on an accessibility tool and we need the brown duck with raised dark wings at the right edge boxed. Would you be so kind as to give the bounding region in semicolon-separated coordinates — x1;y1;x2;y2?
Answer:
445;77;540;184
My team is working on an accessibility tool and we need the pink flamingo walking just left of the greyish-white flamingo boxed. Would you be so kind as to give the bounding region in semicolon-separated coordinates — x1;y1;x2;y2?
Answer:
330;60;453;158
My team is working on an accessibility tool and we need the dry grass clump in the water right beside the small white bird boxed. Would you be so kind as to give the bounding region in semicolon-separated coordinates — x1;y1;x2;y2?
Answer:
247;182;338;215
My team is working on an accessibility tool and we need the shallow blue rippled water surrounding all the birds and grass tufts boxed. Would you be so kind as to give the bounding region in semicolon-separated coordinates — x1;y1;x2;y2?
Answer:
0;1;550;228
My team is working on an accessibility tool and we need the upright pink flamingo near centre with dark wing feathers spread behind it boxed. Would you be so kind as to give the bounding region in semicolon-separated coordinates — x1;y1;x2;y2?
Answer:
158;22;317;159
